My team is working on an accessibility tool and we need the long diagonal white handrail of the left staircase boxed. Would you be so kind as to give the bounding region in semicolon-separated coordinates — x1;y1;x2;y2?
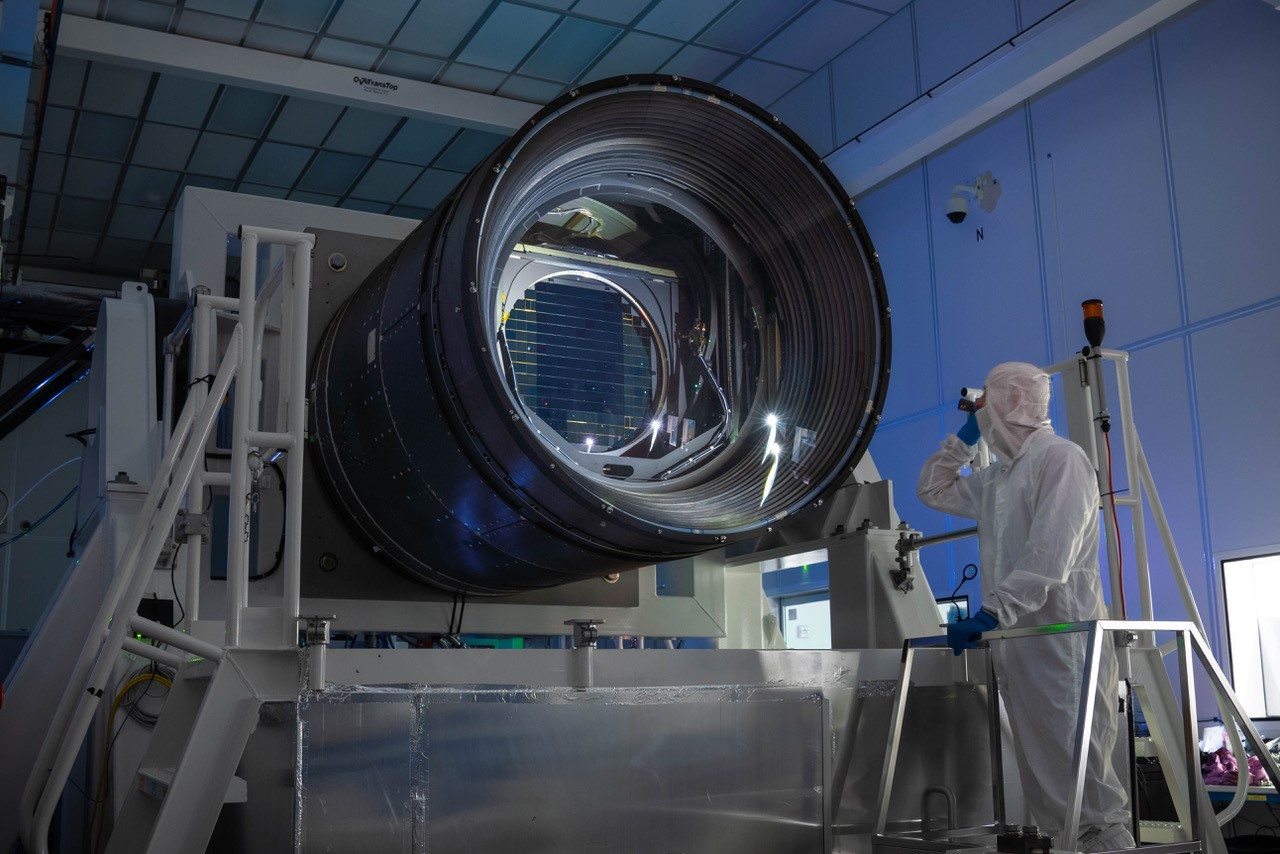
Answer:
19;326;243;854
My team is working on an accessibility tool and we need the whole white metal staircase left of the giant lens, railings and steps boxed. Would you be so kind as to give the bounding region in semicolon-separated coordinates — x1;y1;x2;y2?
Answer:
8;227;314;854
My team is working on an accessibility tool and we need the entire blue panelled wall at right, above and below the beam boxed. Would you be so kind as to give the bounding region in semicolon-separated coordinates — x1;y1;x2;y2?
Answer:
832;0;1280;665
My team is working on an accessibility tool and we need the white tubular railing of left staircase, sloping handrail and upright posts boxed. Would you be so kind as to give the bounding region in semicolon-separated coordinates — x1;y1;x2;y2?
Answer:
19;227;315;854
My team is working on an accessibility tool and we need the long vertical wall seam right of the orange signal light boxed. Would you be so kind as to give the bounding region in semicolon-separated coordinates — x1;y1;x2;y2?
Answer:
1147;29;1222;650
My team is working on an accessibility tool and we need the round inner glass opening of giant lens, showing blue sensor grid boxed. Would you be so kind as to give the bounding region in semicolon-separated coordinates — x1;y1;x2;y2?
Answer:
494;195;760;481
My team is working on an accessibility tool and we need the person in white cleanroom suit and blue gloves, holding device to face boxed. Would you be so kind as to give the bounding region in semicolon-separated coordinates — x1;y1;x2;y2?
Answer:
916;362;1134;851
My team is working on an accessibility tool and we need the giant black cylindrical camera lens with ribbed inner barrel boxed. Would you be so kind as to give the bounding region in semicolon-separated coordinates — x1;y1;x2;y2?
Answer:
314;77;888;593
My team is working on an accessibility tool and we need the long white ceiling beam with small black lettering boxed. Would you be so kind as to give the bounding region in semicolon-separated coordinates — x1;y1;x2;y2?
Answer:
58;15;540;134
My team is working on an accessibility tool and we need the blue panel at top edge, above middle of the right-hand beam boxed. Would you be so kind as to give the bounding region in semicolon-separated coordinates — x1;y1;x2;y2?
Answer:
915;0;1018;91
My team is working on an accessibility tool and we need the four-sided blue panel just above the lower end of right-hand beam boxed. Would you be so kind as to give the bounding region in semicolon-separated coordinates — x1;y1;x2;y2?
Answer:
831;8;918;146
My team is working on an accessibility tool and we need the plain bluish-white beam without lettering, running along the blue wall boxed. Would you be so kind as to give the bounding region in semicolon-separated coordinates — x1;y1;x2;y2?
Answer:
826;0;1199;197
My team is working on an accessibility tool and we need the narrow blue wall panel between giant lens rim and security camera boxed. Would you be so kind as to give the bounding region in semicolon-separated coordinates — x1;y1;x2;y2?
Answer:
858;166;941;423
